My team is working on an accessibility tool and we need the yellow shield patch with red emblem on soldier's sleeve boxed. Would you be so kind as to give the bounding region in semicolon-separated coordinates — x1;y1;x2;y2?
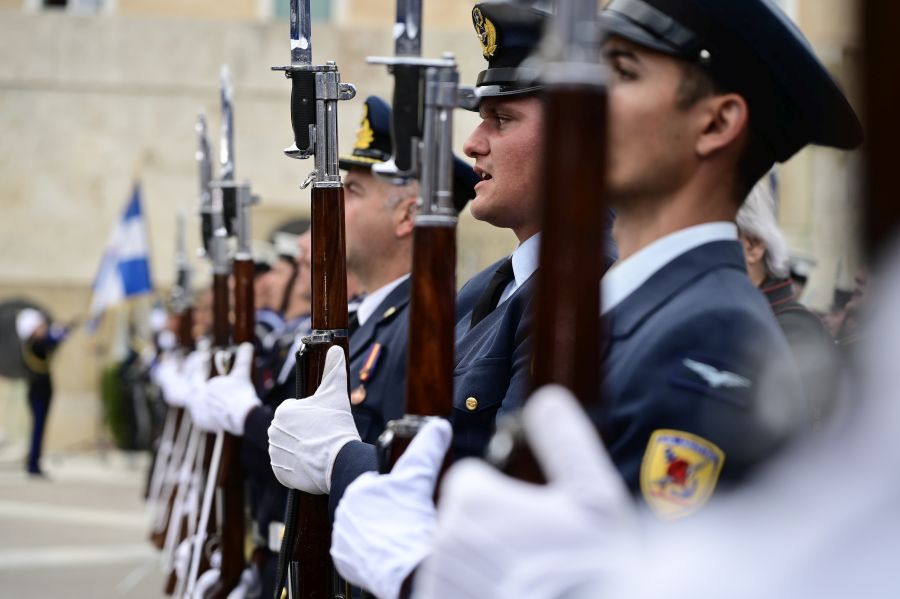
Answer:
641;430;725;520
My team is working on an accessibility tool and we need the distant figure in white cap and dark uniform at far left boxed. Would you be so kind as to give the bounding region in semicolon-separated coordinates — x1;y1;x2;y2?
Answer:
16;308;69;477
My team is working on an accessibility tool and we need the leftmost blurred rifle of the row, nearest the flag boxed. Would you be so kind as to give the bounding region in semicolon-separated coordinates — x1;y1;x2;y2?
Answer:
149;211;194;549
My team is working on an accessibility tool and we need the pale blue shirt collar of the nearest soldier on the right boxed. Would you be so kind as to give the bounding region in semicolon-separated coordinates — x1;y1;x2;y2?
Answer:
601;222;738;314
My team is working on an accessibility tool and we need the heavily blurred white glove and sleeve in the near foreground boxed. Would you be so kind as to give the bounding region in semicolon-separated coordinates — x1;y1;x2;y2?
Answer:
416;238;900;599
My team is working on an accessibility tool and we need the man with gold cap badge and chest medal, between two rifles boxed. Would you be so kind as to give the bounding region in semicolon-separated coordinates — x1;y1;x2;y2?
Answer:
340;96;476;443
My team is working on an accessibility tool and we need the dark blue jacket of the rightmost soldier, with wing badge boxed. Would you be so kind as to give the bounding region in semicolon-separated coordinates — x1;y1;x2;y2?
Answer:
592;241;804;490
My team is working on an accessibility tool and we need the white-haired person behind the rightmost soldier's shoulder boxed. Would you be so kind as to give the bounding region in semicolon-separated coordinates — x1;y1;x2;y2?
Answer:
736;175;838;428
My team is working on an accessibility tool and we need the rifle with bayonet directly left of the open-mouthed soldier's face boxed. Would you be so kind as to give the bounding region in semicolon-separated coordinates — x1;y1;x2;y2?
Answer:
367;0;459;472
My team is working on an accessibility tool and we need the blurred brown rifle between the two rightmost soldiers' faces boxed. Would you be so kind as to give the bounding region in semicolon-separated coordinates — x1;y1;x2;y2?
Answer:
488;0;608;482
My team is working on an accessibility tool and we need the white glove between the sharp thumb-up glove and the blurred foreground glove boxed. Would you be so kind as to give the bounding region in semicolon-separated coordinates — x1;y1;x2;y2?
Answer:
331;418;453;599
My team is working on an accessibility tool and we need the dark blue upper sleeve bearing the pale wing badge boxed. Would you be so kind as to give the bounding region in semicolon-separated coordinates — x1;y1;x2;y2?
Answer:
604;308;805;492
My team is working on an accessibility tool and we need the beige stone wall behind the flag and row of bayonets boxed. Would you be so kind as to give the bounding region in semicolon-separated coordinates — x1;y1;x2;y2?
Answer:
0;8;515;454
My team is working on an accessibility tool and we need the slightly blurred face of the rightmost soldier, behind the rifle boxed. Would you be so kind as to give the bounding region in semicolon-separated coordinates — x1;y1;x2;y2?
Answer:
603;38;704;208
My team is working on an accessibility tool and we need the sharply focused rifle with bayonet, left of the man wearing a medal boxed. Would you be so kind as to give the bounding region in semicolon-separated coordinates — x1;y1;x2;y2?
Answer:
273;0;356;599
